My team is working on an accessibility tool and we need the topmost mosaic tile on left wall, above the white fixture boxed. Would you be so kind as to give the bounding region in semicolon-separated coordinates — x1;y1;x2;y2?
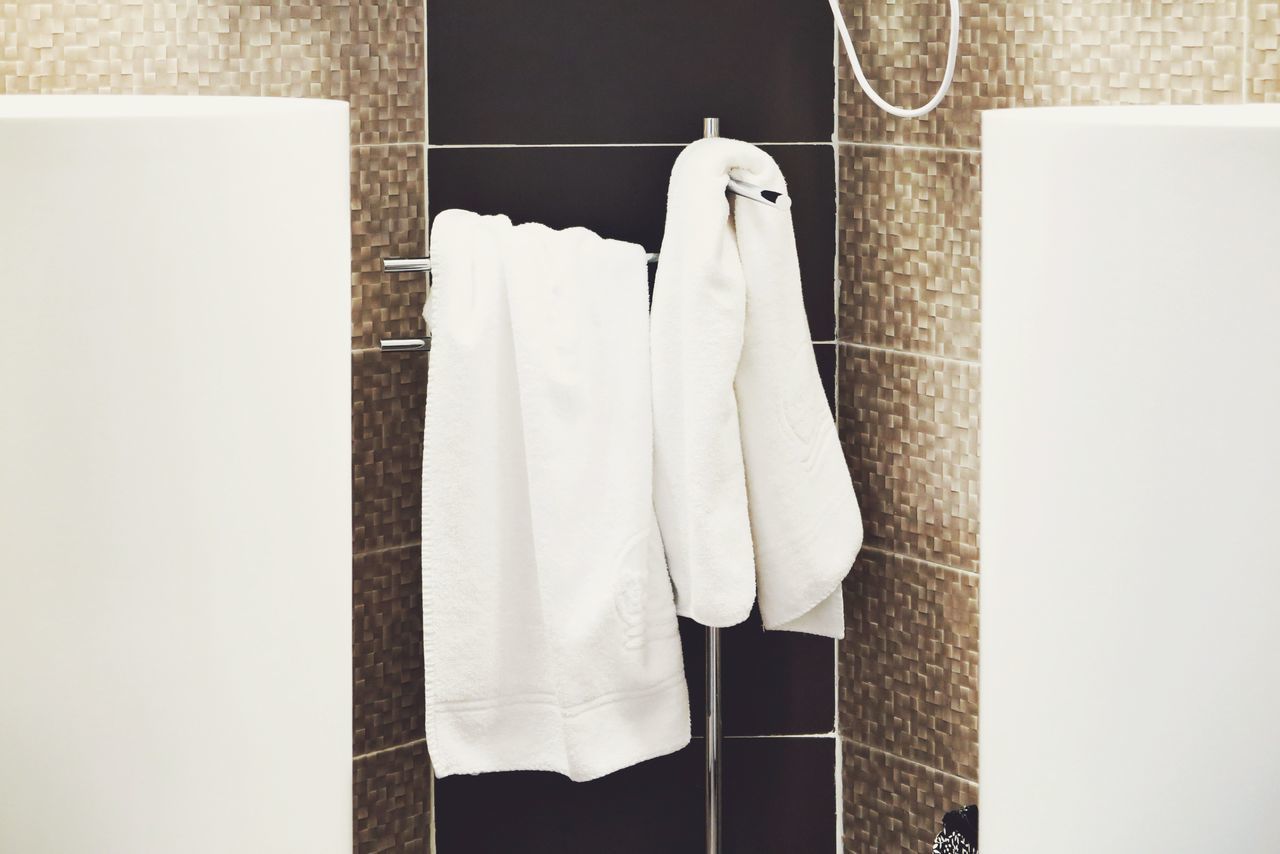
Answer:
0;0;426;143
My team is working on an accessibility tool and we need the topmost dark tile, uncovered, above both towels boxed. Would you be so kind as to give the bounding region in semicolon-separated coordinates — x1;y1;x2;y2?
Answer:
426;0;835;143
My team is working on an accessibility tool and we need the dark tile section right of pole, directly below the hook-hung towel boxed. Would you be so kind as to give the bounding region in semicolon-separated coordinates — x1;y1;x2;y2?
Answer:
721;608;836;735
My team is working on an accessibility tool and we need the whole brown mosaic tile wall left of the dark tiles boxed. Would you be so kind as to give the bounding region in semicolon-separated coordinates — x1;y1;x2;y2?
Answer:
0;0;430;853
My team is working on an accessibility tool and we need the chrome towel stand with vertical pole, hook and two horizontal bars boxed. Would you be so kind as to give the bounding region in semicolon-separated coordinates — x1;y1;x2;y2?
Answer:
379;118;773;854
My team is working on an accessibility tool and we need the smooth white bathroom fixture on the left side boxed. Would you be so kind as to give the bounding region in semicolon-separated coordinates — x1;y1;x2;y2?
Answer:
0;96;351;854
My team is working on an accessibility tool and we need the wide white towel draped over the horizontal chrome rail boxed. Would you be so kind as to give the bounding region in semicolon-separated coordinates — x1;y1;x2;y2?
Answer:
422;211;689;780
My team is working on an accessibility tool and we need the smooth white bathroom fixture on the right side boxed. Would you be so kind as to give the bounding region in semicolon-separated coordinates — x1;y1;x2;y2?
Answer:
980;105;1280;854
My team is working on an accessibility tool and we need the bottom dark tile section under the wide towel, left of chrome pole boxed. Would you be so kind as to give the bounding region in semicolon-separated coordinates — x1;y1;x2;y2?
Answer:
435;740;701;854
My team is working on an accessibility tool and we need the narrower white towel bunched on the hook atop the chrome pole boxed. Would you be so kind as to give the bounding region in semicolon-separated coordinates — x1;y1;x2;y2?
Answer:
650;140;863;638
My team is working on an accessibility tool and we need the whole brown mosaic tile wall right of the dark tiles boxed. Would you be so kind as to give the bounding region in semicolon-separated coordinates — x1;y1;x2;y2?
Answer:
837;0;1280;854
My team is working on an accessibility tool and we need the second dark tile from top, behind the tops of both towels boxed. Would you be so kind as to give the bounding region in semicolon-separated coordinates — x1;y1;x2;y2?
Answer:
428;145;836;341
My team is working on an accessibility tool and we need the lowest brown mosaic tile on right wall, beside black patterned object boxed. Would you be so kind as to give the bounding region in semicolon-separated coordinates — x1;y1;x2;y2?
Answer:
844;739;978;854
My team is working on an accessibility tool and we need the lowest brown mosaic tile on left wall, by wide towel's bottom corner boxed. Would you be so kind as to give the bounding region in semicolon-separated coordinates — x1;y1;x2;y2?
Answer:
352;741;431;854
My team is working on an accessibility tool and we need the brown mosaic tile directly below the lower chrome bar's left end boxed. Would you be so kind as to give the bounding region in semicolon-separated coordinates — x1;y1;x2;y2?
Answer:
351;350;428;554
